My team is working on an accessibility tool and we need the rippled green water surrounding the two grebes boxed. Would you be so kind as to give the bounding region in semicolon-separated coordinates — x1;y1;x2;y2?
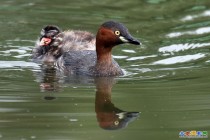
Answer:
0;0;210;140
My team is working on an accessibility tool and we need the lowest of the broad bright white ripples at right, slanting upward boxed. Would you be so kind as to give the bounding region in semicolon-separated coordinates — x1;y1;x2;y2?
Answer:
153;53;205;65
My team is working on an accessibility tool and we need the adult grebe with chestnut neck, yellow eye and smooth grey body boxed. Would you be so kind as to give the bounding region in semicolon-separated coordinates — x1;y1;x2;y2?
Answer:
56;21;140;76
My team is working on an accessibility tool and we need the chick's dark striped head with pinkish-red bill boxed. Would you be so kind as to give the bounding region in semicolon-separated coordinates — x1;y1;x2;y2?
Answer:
39;25;61;46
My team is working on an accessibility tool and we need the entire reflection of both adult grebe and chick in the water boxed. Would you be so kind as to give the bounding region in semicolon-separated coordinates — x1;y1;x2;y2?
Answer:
33;65;139;130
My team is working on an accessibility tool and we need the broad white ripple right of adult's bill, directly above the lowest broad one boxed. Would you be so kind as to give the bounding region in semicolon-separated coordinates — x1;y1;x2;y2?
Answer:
158;43;210;53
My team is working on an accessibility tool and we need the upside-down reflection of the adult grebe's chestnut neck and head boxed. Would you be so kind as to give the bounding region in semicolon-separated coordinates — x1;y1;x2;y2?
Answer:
95;77;139;130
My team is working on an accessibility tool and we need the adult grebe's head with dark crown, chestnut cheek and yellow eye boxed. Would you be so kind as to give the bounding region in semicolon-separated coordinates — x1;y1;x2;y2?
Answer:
96;21;140;47
